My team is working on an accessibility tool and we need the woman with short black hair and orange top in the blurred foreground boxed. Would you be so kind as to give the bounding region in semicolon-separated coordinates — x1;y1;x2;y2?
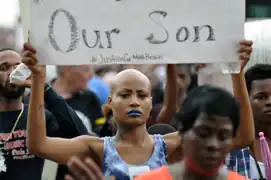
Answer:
135;85;251;180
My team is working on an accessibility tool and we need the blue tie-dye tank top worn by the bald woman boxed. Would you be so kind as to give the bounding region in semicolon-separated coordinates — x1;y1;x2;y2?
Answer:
103;135;167;180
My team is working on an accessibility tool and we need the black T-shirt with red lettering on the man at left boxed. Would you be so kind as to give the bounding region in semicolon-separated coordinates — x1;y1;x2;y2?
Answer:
0;104;58;180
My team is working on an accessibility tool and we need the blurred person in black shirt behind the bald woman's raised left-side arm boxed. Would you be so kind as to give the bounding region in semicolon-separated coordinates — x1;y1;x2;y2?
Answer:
51;65;105;134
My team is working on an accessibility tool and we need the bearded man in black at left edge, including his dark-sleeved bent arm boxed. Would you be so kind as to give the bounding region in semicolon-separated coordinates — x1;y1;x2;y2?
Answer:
0;49;87;180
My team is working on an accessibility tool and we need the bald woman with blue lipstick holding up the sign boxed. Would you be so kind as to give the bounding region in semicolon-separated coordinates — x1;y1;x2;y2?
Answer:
23;40;255;180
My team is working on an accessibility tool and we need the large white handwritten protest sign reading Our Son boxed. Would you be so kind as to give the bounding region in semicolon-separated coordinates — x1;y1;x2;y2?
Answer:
30;0;245;65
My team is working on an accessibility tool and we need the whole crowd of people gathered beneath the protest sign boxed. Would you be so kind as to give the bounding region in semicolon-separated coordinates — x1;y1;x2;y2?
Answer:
0;9;271;180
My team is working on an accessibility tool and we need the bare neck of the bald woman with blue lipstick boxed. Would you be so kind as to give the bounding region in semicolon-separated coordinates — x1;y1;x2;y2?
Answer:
113;124;151;145
